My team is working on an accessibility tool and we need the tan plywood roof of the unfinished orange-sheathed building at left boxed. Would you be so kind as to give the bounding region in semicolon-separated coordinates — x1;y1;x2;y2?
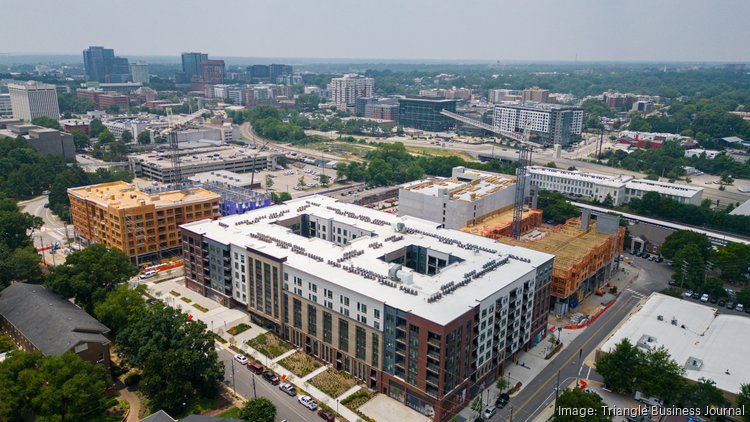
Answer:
68;181;219;209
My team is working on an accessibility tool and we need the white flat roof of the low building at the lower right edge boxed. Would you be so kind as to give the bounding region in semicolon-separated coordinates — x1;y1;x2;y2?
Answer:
601;293;750;394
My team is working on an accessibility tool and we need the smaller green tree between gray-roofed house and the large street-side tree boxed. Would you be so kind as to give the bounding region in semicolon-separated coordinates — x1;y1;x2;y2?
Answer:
94;284;146;335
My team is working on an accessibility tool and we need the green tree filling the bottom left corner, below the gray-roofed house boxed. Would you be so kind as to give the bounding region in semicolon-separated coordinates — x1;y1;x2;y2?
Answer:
0;351;111;421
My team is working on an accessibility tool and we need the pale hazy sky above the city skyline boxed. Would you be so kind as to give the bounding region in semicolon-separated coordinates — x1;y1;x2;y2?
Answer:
0;0;750;62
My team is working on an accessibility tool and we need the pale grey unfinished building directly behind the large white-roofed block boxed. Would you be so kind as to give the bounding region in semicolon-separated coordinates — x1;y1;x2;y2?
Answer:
398;167;516;229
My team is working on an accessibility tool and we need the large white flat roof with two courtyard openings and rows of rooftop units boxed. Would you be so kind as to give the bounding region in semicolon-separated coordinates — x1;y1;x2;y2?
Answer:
181;195;553;325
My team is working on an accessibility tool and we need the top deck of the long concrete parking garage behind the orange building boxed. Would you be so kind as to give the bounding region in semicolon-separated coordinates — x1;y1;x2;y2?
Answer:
128;146;274;169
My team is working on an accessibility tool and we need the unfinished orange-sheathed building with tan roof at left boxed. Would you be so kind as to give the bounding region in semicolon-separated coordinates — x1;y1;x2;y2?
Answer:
68;181;221;259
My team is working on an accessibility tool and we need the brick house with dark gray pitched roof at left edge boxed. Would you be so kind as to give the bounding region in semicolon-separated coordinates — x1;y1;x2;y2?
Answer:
0;283;110;368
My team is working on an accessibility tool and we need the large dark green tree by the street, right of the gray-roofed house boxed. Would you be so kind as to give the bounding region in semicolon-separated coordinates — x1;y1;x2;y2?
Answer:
117;302;224;413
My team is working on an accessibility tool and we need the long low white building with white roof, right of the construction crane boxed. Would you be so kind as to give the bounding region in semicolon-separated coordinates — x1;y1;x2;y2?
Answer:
528;166;703;205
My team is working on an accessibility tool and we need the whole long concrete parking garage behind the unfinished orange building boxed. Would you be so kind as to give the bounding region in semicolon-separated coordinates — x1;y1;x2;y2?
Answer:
128;146;278;183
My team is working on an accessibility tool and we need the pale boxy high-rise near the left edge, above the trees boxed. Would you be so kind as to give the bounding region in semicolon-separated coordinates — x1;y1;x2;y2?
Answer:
8;81;60;121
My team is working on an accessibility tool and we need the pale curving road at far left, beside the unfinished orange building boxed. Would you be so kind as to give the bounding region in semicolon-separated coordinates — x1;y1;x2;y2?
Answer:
18;195;73;265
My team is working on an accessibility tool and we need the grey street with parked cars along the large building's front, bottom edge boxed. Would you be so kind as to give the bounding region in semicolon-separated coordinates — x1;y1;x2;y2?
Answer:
216;344;321;422
